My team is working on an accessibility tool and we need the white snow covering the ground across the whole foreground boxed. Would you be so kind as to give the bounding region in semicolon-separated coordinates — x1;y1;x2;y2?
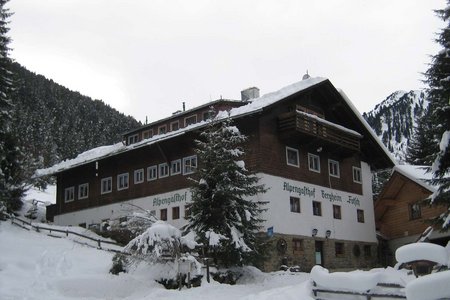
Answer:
0;221;450;300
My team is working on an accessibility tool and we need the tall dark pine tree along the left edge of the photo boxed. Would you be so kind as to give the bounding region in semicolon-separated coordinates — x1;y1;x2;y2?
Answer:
0;0;25;211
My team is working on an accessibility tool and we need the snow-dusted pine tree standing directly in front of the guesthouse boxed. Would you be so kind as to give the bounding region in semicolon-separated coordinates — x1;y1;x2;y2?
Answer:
185;118;266;267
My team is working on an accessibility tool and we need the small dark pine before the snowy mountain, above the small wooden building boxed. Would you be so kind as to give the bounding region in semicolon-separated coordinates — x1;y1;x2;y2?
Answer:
405;109;437;166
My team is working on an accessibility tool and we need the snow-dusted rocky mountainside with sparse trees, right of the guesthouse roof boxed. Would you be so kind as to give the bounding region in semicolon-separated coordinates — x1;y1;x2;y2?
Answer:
363;90;428;161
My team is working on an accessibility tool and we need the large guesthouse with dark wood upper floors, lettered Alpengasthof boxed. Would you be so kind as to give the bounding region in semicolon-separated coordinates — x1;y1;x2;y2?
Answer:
39;77;395;270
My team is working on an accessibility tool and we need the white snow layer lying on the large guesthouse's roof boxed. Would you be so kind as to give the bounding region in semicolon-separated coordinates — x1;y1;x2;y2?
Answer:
35;77;395;177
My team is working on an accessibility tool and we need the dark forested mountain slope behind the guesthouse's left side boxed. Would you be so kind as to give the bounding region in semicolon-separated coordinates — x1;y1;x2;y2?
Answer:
11;63;140;168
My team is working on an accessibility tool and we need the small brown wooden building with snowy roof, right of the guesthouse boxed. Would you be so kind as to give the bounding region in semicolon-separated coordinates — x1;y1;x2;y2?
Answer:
375;165;450;265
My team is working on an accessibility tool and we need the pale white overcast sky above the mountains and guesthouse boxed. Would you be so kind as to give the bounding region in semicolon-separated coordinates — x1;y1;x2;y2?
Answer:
7;0;446;122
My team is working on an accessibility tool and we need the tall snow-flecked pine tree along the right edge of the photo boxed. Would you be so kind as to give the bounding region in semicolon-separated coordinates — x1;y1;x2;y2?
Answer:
425;1;450;231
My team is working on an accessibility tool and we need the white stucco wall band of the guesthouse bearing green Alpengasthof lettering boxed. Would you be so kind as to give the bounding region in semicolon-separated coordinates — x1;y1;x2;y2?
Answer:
55;163;377;242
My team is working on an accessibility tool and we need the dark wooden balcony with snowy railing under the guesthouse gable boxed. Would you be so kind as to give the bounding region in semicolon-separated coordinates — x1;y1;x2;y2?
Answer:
278;110;362;153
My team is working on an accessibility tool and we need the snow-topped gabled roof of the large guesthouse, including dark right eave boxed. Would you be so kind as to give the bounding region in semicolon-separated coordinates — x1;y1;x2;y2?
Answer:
36;77;395;176
